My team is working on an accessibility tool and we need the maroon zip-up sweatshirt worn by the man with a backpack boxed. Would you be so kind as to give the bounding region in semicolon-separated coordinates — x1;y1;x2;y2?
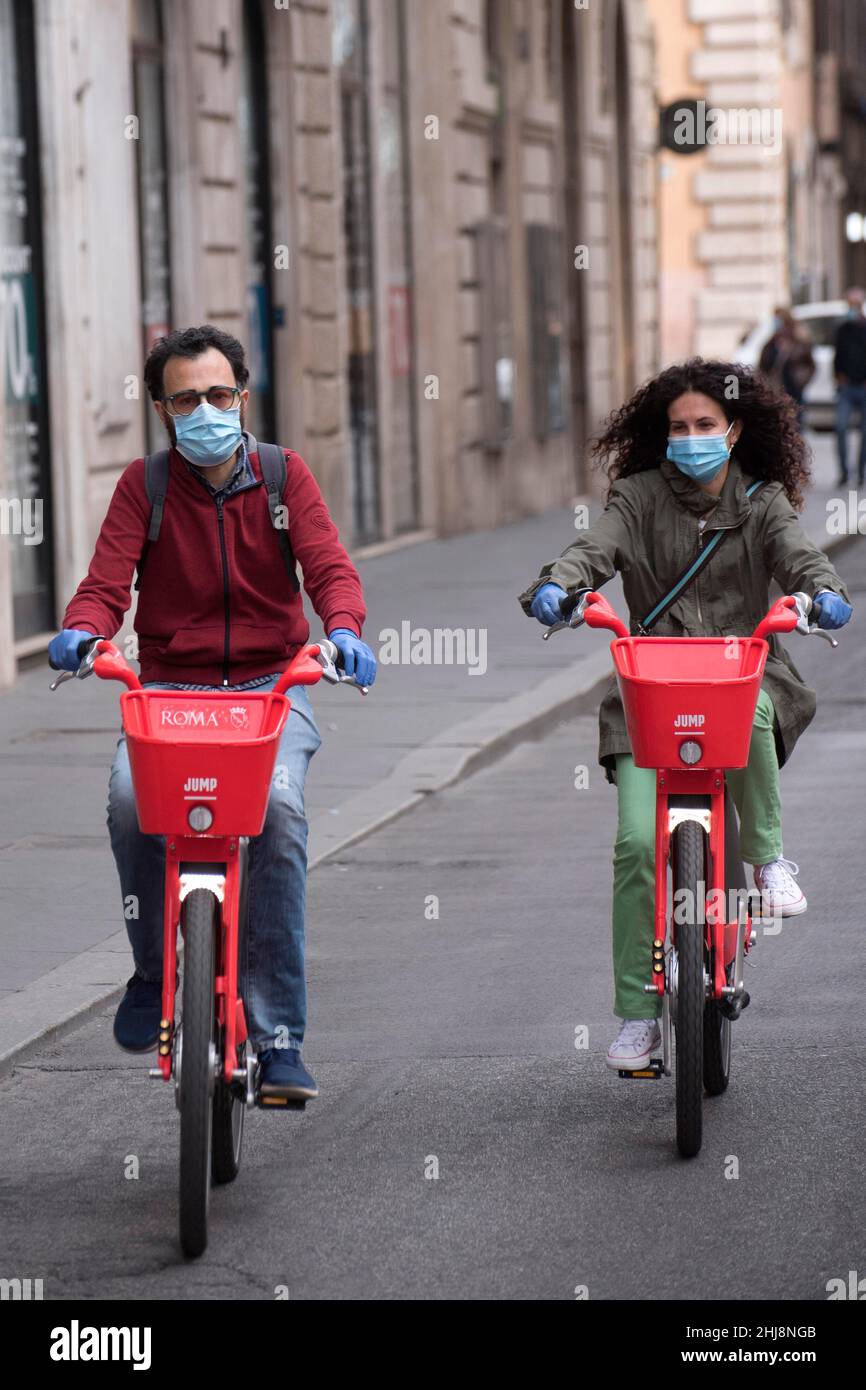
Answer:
63;436;366;685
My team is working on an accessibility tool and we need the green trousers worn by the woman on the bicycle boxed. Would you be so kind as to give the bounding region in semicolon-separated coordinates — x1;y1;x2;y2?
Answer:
613;689;781;1019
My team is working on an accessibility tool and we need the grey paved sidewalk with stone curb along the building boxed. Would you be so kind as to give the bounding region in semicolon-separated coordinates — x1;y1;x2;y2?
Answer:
0;435;856;1069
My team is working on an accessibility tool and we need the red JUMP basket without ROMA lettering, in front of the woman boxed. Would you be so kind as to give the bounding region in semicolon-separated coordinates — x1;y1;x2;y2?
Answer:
610;637;769;771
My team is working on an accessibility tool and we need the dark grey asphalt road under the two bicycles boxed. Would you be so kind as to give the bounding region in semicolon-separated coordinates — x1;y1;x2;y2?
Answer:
0;541;866;1301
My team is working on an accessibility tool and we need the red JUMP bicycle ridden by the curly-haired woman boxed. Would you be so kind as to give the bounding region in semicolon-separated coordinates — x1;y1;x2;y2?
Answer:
545;592;838;1158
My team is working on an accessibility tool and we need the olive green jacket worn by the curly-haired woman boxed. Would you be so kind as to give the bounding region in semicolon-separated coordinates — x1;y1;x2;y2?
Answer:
520;459;851;780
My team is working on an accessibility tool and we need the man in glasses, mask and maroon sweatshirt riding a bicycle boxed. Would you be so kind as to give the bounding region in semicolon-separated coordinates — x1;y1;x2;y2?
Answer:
49;325;375;1101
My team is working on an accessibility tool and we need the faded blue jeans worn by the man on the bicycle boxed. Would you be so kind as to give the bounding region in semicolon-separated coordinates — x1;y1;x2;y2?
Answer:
108;680;321;1051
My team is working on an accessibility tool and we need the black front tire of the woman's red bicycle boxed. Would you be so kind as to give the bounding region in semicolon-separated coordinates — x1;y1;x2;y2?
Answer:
674;820;706;1158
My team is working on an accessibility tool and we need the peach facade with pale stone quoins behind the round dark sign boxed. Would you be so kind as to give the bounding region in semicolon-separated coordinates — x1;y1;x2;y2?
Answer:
651;0;845;360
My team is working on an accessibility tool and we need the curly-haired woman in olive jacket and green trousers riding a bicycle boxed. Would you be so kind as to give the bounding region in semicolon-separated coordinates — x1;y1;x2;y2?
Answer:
520;359;852;1070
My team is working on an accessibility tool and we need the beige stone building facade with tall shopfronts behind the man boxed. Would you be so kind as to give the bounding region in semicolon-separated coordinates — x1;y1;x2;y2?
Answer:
0;0;659;681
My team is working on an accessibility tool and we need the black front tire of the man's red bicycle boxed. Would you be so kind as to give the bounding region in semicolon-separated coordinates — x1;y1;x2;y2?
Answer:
179;888;218;1259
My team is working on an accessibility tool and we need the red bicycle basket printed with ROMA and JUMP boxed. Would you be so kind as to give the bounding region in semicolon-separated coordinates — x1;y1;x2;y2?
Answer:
121;689;291;837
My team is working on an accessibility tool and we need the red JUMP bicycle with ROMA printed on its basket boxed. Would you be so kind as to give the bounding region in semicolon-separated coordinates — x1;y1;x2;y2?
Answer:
51;638;366;1257
